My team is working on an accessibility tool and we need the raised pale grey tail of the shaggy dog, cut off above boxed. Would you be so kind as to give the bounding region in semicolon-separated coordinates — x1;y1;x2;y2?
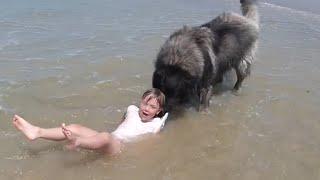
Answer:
240;0;259;25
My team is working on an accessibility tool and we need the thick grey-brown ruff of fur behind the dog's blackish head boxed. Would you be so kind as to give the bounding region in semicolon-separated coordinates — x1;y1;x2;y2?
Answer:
155;26;214;77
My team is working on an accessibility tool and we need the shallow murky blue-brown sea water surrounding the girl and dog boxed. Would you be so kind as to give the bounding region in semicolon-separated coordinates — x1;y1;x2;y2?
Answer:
0;0;320;180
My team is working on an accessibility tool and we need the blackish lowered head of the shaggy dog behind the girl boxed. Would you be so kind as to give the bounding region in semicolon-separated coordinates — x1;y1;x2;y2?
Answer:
152;66;199;111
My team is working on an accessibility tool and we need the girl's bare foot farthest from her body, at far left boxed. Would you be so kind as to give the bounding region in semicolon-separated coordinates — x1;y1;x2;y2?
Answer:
12;115;40;140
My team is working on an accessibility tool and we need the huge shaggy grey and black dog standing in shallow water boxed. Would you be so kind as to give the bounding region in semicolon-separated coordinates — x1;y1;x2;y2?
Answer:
152;0;259;110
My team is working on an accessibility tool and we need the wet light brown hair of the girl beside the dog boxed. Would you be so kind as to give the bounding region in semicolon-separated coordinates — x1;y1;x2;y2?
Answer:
142;88;166;117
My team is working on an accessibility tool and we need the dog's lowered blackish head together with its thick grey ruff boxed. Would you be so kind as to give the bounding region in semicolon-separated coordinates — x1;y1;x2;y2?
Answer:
153;26;214;111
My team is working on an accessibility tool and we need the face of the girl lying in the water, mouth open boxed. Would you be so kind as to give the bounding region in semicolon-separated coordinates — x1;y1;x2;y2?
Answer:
139;95;161;122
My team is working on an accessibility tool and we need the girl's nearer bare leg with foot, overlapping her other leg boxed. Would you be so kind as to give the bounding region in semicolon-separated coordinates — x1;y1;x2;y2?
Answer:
62;127;121;154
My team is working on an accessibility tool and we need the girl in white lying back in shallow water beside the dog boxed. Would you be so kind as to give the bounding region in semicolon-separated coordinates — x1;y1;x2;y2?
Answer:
13;88;168;154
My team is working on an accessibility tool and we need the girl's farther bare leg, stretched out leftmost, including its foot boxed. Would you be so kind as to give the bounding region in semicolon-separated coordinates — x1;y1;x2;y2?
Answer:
13;115;98;141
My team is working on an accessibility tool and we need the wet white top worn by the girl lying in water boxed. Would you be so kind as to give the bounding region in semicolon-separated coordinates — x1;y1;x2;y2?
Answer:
111;105;168;142
